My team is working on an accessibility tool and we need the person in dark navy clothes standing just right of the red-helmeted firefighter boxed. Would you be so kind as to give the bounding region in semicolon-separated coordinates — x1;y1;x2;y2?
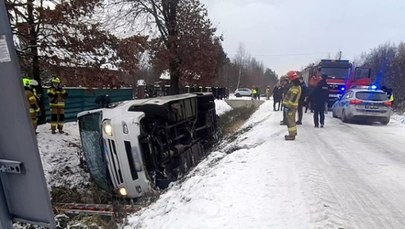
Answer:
310;74;329;128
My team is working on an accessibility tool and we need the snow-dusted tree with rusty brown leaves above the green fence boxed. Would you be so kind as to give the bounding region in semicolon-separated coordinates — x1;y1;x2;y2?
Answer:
6;0;146;122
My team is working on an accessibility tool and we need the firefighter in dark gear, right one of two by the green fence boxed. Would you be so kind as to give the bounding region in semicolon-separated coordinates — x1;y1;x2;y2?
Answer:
48;76;68;134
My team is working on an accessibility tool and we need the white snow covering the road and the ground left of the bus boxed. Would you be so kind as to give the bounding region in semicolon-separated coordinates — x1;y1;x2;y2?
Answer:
38;97;405;229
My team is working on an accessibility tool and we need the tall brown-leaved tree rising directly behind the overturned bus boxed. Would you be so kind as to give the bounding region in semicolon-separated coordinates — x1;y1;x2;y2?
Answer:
105;0;224;94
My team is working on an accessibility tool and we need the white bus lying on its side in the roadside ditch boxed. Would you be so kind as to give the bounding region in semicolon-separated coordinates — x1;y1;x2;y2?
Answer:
78;93;218;198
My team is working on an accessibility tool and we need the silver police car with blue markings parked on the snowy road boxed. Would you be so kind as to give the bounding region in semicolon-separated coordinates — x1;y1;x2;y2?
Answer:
332;87;391;125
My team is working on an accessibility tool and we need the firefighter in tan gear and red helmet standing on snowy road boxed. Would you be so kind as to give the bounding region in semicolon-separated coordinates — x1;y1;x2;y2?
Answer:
283;71;301;141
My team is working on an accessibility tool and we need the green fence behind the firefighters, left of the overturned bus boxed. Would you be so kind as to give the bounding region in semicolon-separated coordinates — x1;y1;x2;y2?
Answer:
42;87;133;122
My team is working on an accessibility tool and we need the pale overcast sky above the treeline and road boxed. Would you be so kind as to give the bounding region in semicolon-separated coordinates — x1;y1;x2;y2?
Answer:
200;0;405;75
